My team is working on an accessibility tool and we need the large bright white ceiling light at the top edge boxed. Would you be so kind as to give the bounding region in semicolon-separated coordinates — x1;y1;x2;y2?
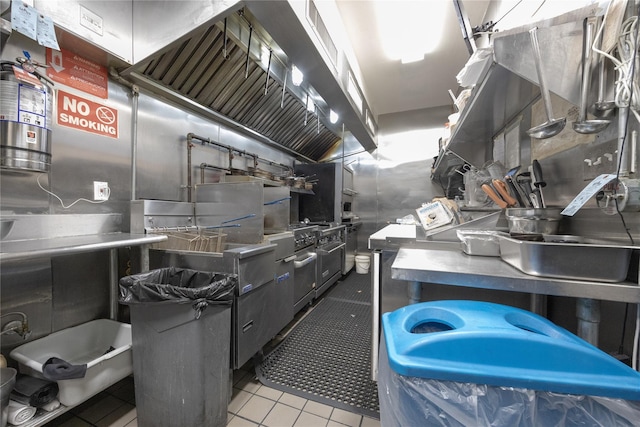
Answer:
375;0;444;63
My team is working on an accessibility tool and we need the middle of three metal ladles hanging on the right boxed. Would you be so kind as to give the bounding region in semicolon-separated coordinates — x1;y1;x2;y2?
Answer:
573;16;611;134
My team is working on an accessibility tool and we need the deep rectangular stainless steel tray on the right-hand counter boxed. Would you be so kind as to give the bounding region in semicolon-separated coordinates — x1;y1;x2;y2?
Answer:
498;233;640;282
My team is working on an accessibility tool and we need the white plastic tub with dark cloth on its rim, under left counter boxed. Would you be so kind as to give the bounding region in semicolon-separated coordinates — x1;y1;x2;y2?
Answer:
10;319;133;406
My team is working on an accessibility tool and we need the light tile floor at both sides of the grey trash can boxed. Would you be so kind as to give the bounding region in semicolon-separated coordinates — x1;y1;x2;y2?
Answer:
46;368;380;427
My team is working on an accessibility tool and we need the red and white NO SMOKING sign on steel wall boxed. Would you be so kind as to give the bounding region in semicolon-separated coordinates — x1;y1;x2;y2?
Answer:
58;90;118;139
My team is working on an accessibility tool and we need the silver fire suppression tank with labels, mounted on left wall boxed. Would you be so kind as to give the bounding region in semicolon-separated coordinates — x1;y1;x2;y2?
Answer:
0;61;53;172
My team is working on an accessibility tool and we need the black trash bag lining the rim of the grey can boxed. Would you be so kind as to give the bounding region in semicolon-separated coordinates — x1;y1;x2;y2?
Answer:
120;267;238;318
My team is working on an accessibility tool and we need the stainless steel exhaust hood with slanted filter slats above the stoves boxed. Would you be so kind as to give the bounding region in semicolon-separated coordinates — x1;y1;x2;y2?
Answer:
121;1;375;161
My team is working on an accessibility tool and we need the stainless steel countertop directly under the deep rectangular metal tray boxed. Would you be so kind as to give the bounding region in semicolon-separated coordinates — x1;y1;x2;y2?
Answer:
391;248;640;303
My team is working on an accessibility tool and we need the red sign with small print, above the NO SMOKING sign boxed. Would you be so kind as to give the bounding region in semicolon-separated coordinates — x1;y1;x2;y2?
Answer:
47;49;108;99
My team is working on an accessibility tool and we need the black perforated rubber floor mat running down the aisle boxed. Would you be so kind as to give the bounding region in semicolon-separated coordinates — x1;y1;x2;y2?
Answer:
256;273;380;418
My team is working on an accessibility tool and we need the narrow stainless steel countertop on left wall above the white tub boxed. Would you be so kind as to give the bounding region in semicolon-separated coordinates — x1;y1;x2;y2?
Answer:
0;233;167;262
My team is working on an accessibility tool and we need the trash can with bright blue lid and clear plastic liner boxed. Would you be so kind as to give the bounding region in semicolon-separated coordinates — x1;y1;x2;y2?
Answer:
378;301;640;427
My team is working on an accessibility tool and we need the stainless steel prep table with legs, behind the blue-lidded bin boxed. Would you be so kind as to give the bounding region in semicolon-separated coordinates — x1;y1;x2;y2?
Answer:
369;221;640;379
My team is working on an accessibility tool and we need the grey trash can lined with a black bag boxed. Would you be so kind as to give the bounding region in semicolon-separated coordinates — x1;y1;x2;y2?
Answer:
120;267;237;427
